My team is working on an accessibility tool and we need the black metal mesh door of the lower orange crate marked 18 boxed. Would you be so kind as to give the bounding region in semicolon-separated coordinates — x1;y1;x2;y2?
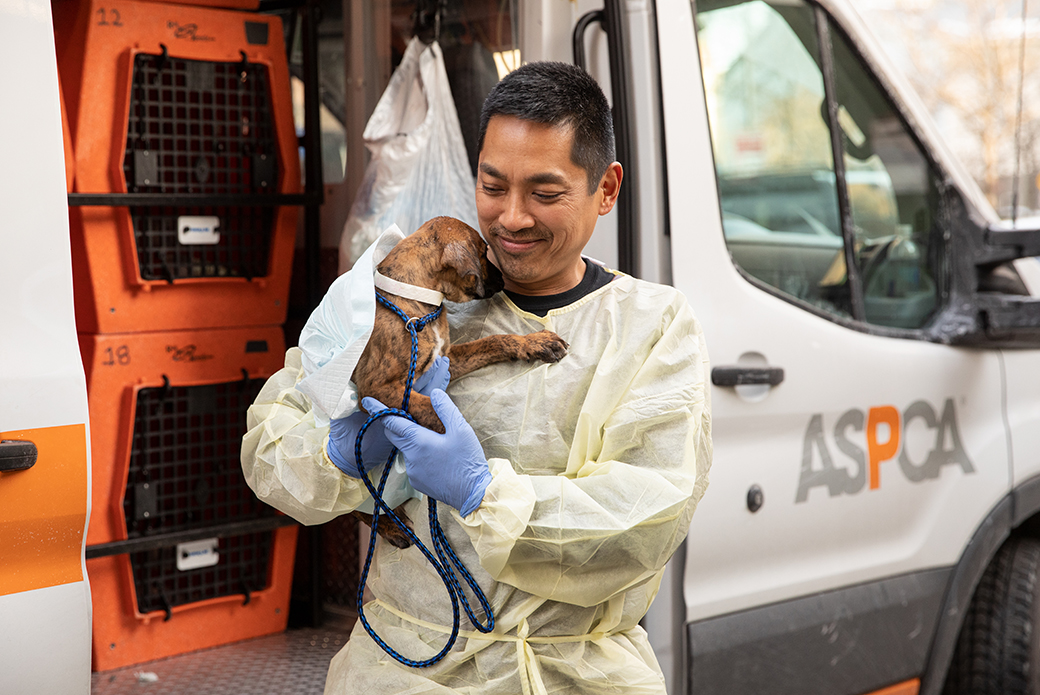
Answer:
123;380;275;613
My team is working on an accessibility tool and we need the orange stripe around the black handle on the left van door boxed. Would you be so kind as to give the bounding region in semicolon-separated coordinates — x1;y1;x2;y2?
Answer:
0;424;87;595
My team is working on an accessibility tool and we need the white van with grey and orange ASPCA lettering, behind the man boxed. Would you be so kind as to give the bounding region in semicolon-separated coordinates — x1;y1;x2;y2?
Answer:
6;0;1040;695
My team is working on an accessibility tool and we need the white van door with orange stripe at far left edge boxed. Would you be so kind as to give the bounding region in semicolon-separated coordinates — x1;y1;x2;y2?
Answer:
0;0;90;695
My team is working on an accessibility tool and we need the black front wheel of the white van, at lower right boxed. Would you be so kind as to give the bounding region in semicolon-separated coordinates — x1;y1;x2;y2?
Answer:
943;538;1040;695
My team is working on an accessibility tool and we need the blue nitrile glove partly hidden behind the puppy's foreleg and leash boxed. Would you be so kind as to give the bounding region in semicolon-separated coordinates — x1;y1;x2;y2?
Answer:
326;357;451;478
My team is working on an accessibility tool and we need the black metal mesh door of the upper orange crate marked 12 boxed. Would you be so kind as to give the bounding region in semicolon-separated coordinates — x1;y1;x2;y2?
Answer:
123;53;280;282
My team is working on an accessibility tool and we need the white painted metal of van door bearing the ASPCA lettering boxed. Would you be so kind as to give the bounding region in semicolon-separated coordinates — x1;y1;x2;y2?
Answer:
657;1;1011;620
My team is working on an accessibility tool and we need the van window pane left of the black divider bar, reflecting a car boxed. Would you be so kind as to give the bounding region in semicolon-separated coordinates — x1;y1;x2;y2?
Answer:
697;0;852;316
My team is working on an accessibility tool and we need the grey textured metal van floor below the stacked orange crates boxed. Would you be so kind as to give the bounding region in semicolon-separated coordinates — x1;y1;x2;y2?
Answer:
90;625;350;695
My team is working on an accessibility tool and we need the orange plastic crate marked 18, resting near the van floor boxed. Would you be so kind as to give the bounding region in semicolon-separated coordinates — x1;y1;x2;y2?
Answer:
80;327;296;671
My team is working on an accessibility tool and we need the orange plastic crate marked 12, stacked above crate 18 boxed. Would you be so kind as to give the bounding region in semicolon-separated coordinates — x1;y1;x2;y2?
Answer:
54;0;301;333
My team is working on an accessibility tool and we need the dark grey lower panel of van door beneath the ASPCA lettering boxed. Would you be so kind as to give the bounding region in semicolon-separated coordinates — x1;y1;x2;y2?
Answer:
686;569;952;695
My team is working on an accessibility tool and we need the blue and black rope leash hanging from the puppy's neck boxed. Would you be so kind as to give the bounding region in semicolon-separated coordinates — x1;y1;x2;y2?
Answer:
354;292;495;668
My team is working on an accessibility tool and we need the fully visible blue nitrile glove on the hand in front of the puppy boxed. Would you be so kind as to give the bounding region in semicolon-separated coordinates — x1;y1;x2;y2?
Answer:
363;389;491;516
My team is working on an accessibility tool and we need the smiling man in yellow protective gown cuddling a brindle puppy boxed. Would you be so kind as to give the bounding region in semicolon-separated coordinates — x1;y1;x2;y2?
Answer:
242;63;711;695
